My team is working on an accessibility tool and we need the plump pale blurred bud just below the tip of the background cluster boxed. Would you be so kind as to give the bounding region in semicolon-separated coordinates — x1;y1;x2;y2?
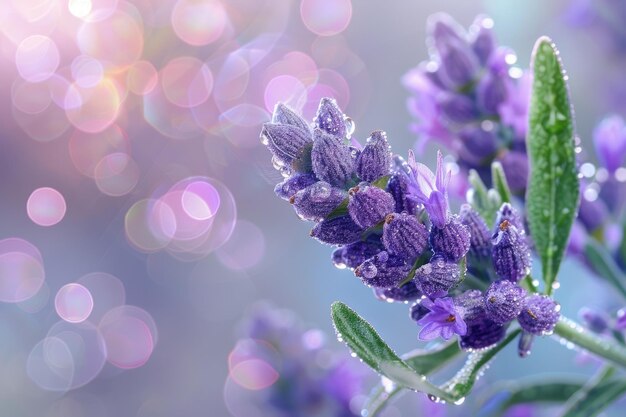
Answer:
439;40;479;88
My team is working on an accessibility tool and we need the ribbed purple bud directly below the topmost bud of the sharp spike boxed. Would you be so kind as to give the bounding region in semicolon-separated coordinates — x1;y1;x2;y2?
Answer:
311;129;354;187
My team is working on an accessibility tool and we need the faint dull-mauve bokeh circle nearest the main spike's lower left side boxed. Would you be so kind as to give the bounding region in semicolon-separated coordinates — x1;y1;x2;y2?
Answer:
215;220;265;270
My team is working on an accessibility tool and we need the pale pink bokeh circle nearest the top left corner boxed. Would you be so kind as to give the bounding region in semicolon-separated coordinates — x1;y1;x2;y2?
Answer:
15;35;60;82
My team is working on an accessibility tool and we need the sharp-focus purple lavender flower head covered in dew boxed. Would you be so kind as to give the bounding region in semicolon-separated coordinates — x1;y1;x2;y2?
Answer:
261;99;559;350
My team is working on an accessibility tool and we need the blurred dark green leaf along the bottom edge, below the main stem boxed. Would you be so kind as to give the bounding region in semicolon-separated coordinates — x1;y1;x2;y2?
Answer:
480;381;583;417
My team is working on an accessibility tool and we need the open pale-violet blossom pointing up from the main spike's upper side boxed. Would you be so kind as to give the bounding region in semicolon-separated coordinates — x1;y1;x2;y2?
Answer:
408;150;451;227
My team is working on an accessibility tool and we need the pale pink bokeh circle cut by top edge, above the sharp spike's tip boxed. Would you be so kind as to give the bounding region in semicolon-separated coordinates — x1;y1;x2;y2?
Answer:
300;0;352;36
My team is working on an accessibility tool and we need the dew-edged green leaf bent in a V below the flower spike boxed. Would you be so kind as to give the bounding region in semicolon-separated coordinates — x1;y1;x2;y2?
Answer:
331;302;520;412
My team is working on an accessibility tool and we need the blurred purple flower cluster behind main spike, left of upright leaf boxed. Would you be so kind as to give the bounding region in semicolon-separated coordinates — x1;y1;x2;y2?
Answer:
404;14;530;193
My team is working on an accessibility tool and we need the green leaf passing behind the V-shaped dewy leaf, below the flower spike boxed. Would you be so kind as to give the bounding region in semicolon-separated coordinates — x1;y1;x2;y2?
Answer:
362;340;463;417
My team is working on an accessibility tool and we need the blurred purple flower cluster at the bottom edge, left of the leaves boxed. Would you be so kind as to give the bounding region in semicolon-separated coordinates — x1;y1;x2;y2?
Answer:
229;305;368;417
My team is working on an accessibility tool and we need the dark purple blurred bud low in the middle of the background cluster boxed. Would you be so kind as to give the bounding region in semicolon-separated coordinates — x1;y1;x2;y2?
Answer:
458;125;500;167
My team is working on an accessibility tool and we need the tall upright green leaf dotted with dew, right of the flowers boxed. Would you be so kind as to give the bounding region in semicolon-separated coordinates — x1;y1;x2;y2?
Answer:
526;37;579;294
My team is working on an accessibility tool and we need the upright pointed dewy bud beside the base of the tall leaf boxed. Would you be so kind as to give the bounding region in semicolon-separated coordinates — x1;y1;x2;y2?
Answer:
491;220;531;282
